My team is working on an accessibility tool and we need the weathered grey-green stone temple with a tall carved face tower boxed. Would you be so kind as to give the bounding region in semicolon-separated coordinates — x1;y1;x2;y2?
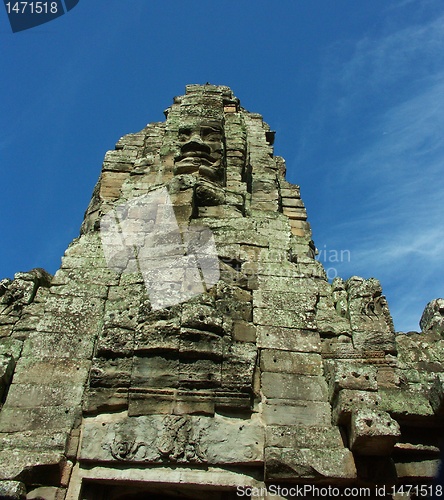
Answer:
0;84;444;500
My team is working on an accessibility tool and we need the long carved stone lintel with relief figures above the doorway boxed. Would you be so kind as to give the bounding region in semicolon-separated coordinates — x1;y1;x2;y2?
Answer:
80;415;264;465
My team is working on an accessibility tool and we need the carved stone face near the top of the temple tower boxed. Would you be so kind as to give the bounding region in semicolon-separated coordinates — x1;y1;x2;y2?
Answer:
174;122;223;182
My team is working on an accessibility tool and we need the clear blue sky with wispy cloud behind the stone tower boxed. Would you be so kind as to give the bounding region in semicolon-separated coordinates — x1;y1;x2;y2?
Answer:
0;0;444;331
